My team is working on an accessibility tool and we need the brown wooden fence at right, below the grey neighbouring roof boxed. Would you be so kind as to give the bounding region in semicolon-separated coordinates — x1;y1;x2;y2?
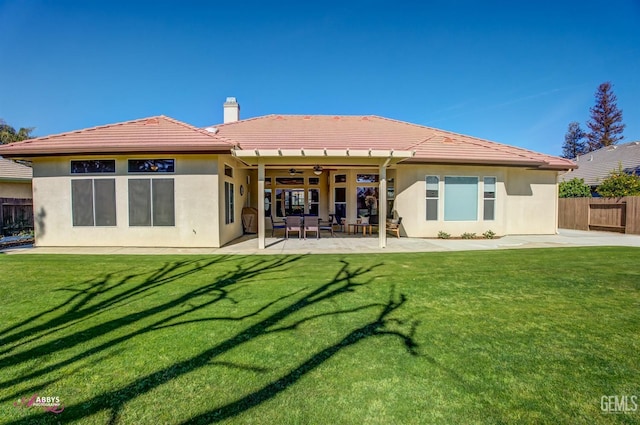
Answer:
558;196;640;235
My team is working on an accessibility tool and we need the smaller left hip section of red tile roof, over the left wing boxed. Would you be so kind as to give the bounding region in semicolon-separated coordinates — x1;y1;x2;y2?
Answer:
0;115;233;157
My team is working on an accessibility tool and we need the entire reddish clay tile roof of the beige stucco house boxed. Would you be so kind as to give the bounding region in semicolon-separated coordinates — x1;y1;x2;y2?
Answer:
0;115;575;170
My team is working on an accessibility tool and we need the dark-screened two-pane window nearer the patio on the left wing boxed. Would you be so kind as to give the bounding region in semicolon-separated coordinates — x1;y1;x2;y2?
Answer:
129;179;175;226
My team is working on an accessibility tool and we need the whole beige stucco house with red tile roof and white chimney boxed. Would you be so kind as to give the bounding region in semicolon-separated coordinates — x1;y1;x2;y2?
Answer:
0;98;575;248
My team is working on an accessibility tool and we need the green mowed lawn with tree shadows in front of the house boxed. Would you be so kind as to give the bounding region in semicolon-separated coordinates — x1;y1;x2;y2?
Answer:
0;248;640;424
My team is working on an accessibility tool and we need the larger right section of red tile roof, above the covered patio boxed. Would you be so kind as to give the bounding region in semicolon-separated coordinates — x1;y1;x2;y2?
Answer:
214;115;575;170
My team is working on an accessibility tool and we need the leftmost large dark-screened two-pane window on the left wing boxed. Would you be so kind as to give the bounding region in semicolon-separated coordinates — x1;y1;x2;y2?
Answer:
71;179;116;226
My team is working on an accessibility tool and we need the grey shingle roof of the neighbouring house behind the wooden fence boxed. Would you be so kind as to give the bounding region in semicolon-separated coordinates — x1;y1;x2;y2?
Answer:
560;141;640;186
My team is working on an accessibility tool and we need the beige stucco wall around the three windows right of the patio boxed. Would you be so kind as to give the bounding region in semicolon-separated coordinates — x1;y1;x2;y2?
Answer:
394;165;558;237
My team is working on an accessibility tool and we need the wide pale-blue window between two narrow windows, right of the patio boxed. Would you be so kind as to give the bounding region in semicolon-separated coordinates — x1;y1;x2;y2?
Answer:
444;176;478;221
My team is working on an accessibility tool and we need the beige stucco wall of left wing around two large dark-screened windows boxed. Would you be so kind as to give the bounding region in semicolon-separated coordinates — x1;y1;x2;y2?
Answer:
33;154;230;247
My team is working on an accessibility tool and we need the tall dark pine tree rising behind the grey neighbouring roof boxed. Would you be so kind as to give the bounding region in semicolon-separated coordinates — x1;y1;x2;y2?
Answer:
587;81;625;151
